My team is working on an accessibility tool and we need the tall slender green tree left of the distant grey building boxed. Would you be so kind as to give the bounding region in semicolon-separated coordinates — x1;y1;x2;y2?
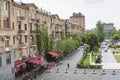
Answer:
96;21;105;42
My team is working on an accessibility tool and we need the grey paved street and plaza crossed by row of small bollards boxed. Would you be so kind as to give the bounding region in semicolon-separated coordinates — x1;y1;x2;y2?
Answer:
36;48;120;80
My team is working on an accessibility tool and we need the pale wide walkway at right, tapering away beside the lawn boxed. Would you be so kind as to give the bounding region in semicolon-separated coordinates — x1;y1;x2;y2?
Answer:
102;49;120;69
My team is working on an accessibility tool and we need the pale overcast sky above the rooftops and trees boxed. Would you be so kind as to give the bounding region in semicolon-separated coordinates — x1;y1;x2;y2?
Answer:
15;0;120;29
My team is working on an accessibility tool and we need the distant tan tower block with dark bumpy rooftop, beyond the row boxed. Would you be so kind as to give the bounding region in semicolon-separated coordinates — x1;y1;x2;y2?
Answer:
70;12;85;32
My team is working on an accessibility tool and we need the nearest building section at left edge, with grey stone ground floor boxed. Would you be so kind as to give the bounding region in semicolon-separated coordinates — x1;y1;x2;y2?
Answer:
0;0;15;80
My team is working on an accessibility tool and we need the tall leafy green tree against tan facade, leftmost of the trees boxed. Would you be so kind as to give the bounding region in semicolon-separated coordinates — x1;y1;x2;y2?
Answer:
37;28;54;53
